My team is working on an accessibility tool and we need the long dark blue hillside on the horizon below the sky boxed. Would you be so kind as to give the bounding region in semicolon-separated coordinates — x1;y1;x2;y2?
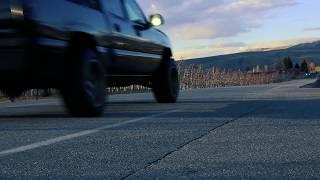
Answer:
180;41;320;70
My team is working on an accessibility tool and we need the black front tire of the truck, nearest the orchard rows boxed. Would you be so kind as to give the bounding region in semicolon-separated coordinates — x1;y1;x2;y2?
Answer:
152;60;180;103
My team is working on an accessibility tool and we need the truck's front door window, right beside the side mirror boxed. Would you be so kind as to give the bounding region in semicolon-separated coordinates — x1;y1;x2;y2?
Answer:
125;0;147;24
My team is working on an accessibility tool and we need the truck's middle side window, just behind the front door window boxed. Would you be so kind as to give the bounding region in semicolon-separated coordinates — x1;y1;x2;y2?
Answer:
101;0;125;18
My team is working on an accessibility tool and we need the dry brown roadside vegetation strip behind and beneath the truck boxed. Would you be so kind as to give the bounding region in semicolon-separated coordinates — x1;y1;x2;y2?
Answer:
0;64;294;99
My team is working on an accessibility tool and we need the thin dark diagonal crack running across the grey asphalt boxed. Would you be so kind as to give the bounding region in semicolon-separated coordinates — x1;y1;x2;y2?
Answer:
121;103;270;180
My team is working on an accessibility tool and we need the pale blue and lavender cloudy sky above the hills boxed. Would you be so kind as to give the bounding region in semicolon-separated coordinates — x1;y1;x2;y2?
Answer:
137;0;320;60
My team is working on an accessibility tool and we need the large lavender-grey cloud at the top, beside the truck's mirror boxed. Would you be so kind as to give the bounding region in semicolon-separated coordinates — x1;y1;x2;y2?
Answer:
138;0;296;41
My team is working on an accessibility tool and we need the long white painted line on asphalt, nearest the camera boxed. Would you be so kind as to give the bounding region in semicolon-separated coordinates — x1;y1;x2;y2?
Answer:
0;109;179;157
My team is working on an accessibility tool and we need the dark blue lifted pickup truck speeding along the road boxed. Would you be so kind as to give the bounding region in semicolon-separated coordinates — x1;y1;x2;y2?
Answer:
0;0;179;117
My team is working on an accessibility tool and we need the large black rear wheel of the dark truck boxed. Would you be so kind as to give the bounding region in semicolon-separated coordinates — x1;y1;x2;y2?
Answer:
61;48;106;117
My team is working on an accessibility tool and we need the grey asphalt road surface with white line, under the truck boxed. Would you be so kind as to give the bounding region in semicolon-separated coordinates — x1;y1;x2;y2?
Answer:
0;80;320;179
